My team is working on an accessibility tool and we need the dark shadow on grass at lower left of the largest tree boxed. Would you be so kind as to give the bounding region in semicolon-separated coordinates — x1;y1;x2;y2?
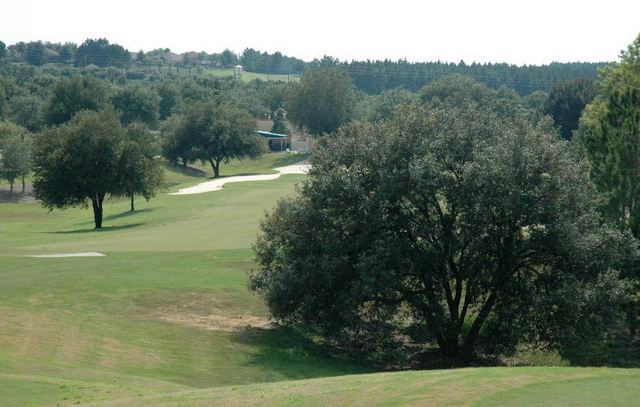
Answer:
233;326;375;379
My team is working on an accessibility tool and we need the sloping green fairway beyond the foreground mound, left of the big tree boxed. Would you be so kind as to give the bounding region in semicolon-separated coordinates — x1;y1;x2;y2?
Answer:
0;156;363;402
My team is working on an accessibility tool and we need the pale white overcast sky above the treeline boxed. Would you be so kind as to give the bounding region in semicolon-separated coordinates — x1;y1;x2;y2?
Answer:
0;0;640;65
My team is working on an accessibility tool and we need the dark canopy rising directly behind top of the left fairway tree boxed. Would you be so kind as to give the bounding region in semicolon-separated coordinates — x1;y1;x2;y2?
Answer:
45;76;108;125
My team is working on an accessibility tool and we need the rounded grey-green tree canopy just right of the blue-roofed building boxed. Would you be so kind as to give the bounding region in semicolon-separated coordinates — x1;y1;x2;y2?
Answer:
285;68;356;136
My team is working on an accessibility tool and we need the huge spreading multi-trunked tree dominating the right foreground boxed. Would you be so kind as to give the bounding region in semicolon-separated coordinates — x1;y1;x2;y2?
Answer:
251;107;636;356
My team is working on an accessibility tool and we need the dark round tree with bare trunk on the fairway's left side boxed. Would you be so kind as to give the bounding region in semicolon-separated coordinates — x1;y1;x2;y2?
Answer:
33;111;127;229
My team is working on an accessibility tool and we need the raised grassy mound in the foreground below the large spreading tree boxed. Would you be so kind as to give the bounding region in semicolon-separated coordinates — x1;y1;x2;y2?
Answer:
90;367;640;407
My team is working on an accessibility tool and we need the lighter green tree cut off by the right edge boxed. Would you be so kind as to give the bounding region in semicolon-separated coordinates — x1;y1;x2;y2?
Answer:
578;36;640;237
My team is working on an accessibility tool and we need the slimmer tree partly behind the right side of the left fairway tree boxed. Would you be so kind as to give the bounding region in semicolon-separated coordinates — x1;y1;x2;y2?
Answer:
118;123;165;212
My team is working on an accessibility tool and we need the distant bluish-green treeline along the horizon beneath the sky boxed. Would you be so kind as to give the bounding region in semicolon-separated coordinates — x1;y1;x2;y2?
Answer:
0;38;604;95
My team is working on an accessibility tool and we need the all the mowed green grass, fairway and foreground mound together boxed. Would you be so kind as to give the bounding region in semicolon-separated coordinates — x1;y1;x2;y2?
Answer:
0;154;640;406
